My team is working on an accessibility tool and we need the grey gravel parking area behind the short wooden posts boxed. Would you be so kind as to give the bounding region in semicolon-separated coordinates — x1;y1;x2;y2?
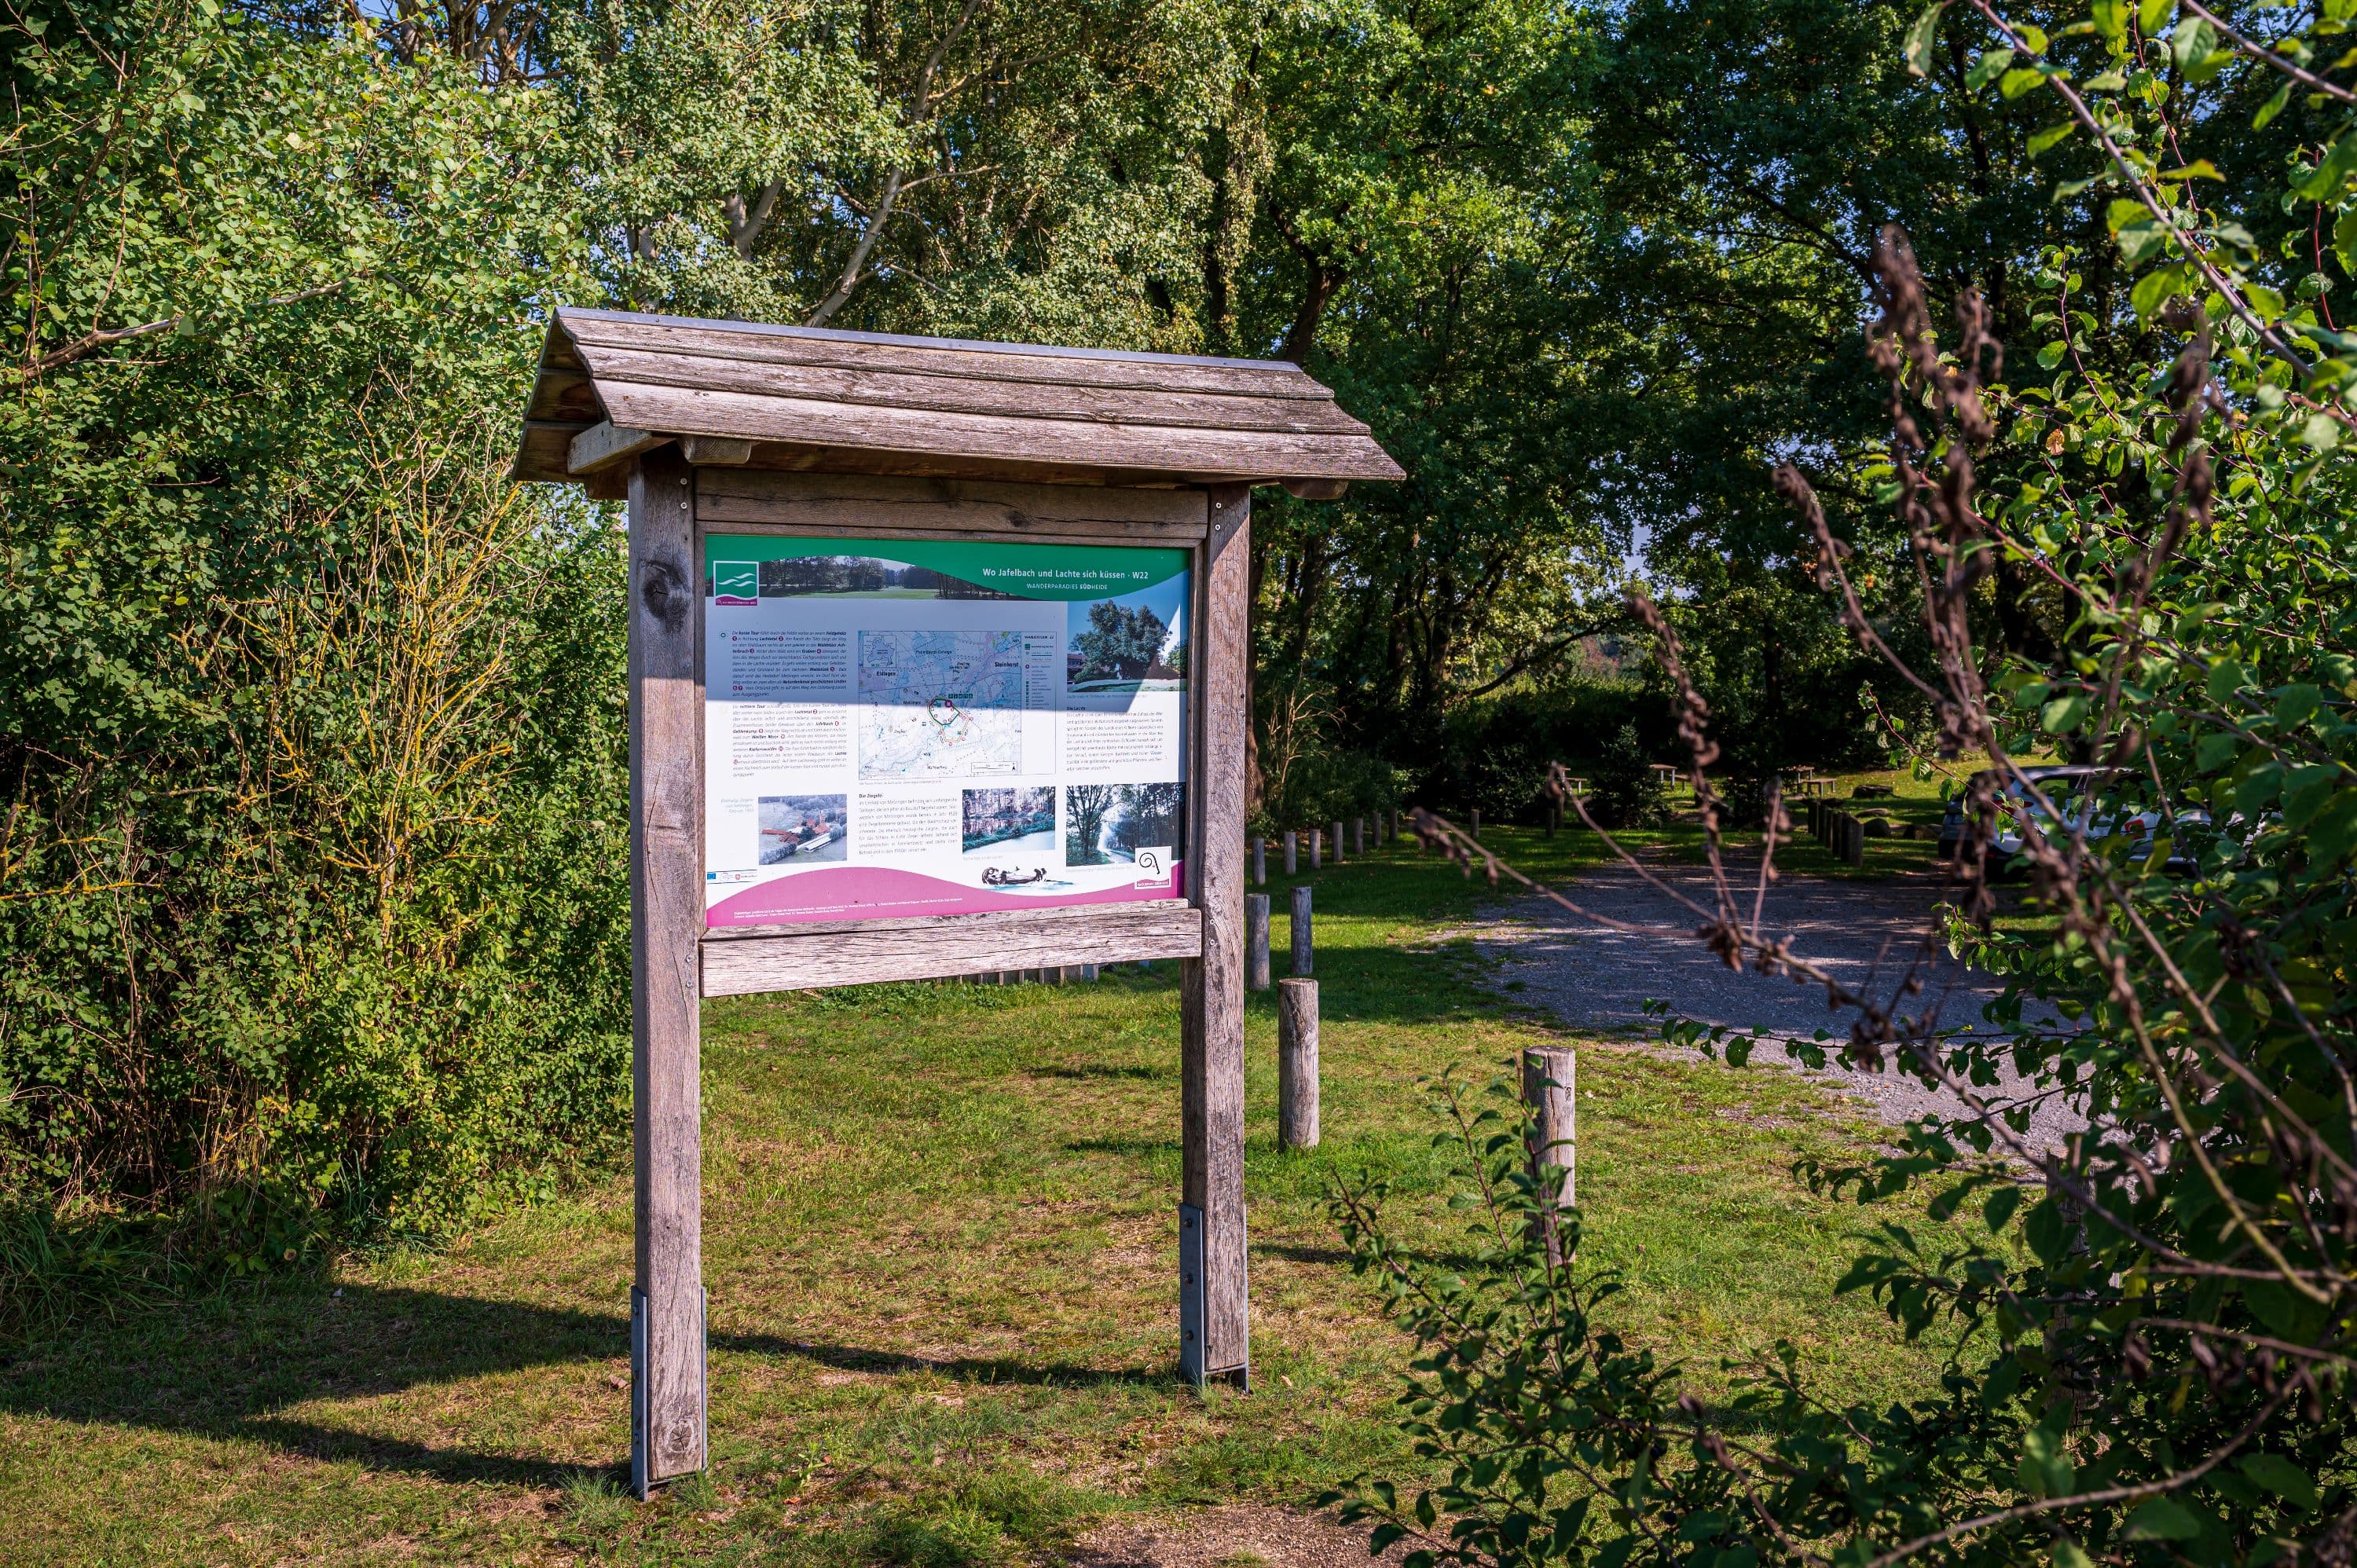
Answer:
1471;863;2086;1149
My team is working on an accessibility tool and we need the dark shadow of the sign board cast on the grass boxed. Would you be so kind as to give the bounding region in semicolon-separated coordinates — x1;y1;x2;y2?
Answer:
0;1280;1176;1488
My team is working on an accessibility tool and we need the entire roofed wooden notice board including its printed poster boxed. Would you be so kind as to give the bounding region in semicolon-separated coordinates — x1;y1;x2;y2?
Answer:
514;306;1402;1471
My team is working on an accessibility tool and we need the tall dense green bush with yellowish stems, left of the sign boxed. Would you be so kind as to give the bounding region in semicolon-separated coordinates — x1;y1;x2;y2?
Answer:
0;5;629;1269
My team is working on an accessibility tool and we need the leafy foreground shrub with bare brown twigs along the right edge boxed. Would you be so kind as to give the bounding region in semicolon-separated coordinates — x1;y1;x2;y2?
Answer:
1339;0;2357;1568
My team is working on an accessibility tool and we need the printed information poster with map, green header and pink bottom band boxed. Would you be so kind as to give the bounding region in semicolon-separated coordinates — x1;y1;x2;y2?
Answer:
705;535;1190;927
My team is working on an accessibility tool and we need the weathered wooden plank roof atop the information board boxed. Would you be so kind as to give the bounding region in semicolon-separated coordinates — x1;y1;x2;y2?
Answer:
514;309;1402;495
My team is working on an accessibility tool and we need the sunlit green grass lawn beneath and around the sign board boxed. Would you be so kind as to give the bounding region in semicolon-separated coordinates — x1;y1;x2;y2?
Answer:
0;828;1970;1568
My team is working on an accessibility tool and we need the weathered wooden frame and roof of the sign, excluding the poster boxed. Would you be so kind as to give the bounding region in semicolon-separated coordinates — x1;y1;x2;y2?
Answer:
514;309;1400;1497
